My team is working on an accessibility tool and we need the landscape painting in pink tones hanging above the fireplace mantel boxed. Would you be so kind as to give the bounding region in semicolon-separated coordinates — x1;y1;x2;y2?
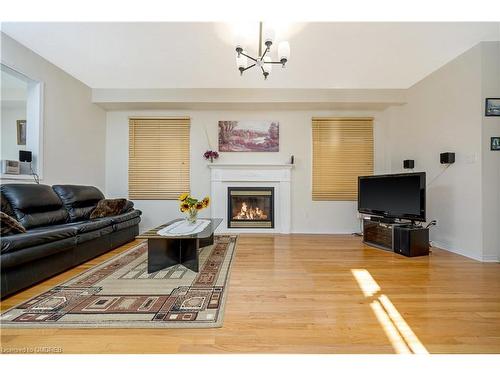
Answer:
219;121;280;152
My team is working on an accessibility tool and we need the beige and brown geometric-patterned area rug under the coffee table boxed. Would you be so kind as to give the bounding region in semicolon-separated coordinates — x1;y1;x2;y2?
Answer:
0;236;237;328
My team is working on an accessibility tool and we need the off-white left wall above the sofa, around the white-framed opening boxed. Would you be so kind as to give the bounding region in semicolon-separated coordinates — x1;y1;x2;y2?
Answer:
1;33;106;189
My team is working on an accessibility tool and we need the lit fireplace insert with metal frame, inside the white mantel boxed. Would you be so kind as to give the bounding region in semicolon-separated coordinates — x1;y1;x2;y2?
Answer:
227;187;274;228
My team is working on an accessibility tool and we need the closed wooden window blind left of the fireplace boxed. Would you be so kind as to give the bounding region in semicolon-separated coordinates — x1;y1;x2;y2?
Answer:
128;117;190;199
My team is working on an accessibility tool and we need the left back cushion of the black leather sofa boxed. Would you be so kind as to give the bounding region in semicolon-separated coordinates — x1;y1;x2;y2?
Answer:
0;184;69;229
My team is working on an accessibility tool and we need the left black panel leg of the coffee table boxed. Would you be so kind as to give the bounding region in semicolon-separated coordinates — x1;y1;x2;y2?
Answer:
148;238;181;273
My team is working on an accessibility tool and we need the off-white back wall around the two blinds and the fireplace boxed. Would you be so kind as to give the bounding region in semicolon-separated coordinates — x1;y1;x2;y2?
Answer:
106;110;384;233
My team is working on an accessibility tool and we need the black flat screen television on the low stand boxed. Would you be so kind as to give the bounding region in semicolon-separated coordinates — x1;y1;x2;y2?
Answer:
358;172;425;221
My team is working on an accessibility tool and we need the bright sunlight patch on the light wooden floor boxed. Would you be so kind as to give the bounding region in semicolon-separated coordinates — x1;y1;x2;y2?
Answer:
351;269;429;354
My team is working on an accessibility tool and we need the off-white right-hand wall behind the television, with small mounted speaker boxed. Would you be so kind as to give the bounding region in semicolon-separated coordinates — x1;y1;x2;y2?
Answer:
384;43;500;260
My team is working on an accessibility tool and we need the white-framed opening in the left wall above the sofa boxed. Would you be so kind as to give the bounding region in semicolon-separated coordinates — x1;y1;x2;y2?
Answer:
0;64;43;182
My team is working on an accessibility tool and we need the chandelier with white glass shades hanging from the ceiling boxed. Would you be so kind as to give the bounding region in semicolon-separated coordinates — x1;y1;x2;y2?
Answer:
236;22;290;79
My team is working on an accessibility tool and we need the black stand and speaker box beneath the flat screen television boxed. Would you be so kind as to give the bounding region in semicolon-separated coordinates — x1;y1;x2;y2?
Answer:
363;217;429;256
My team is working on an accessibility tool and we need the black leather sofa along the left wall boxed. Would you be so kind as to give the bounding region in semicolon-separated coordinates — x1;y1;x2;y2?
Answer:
0;184;141;298
